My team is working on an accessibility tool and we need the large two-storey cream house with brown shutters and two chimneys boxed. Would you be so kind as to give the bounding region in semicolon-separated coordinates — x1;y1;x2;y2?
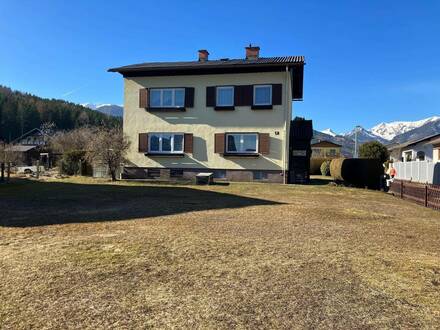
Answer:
109;46;304;182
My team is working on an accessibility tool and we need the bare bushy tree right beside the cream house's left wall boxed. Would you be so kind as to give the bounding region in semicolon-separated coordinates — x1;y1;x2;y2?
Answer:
87;128;130;181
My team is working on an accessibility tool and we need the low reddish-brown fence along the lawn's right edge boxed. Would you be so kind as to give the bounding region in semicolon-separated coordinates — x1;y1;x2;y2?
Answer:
390;180;440;210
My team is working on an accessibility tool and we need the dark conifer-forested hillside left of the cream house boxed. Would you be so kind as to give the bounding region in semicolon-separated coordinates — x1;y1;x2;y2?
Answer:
0;85;122;141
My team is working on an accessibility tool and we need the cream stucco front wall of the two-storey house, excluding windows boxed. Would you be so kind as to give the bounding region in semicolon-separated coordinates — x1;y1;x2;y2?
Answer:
124;72;292;170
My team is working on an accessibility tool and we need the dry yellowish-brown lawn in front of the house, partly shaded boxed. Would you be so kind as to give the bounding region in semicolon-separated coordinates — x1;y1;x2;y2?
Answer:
0;178;440;329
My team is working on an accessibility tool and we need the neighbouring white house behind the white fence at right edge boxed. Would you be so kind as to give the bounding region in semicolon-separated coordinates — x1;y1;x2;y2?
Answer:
388;134;440;162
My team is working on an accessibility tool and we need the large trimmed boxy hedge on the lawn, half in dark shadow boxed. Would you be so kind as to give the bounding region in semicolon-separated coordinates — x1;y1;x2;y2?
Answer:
330;158;384;189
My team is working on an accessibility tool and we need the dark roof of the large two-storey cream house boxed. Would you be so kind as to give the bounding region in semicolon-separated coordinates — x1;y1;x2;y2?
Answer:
108;56;304;73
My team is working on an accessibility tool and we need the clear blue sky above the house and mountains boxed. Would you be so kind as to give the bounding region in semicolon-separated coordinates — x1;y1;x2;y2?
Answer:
0;0;440;132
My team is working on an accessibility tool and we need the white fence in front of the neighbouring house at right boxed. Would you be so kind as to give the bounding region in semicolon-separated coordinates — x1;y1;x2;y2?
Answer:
393;161;440;184
